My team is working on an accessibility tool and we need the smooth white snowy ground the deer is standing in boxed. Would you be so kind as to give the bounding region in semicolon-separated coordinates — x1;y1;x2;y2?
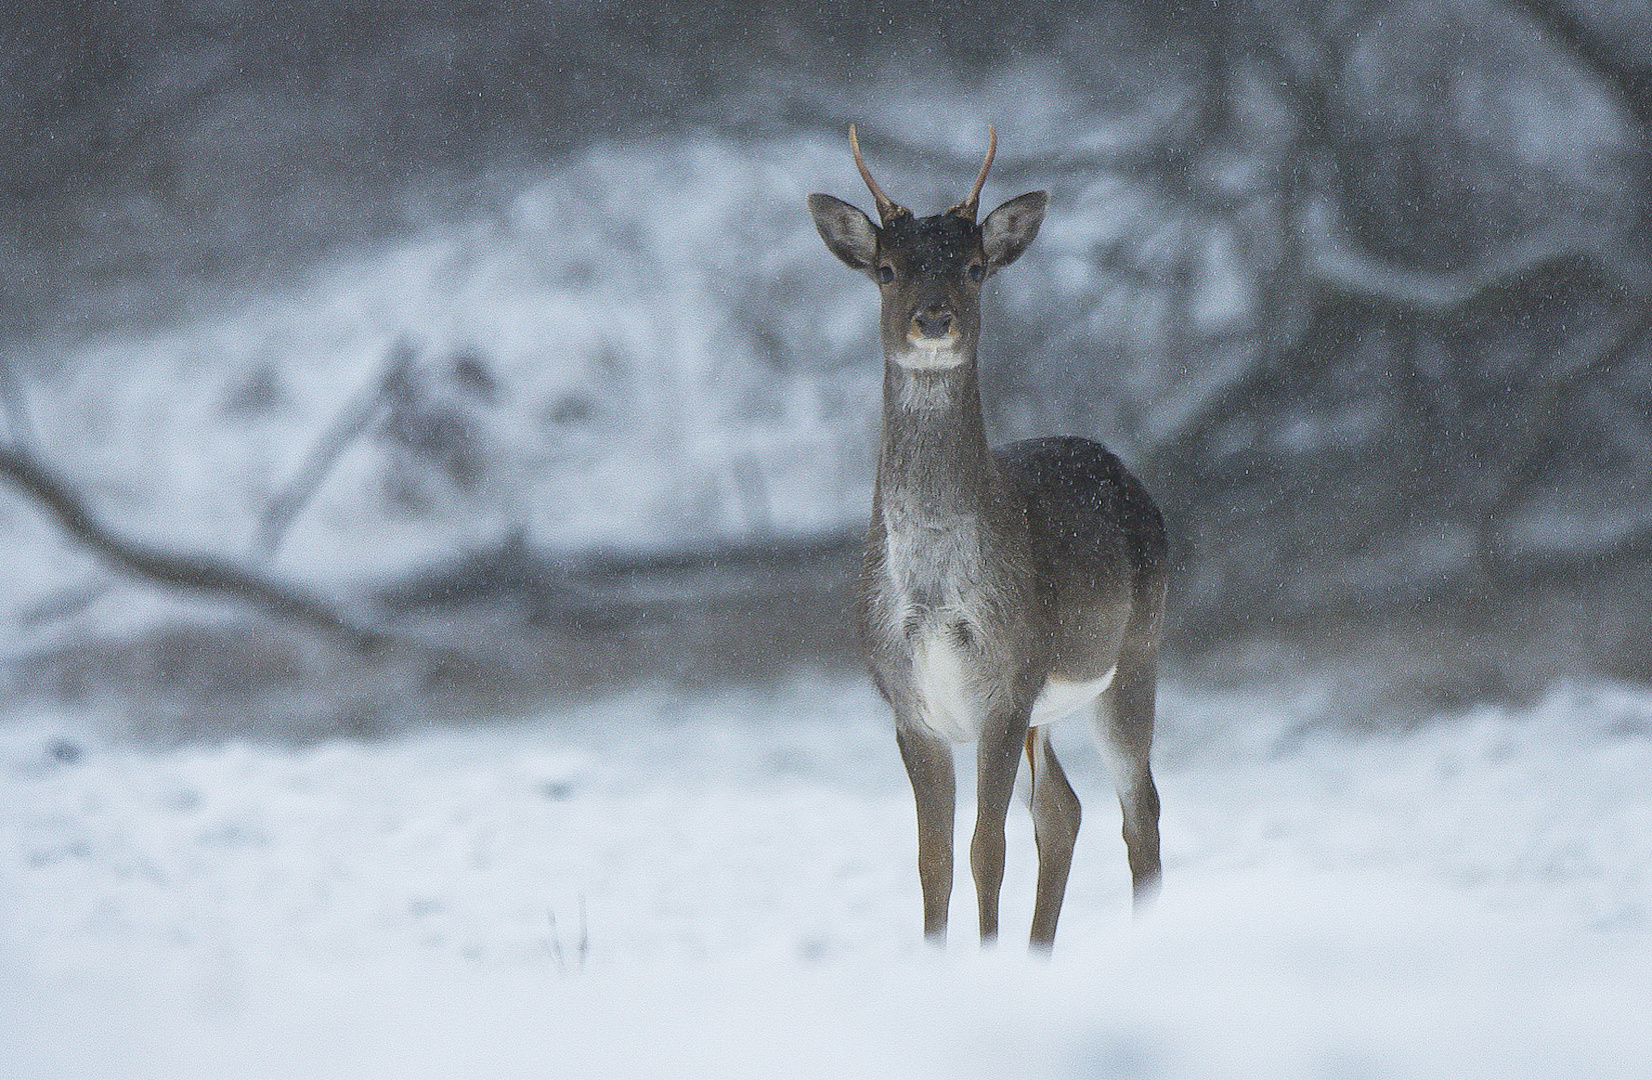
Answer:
0;677;1652;1078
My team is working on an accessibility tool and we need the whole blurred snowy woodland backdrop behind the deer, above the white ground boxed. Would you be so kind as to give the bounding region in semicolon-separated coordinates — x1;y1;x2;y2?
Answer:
0;0;1652;741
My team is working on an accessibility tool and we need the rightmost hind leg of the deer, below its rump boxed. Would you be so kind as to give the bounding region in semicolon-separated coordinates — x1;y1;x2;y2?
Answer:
1095;644;1161;912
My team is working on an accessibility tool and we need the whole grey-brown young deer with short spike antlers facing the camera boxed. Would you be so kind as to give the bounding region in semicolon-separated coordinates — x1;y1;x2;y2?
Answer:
809;126;1168;950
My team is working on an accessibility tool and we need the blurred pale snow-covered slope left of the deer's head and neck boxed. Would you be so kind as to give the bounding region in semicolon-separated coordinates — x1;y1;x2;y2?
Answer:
12;139;879;591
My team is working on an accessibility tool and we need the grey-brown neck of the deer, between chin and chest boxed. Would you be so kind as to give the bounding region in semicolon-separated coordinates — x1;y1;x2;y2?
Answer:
877;353;999;528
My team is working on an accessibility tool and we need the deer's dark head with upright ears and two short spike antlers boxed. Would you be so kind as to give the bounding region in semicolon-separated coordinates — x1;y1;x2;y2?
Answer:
809;124;1049;370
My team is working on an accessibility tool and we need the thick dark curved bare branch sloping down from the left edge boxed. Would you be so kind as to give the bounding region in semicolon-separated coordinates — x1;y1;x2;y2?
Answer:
0;446;390;651
